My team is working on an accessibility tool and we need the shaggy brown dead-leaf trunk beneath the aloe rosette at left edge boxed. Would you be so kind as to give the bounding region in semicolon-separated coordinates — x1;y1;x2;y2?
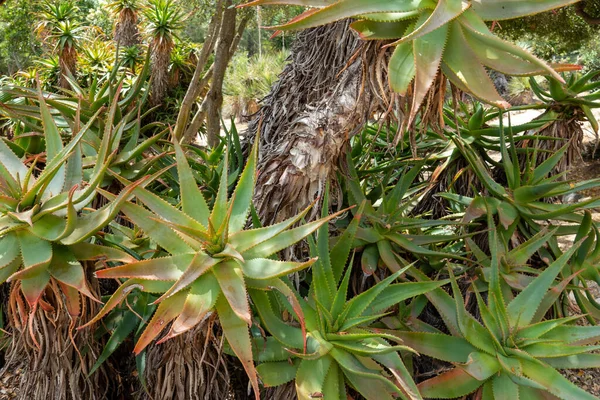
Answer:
0;268;109;400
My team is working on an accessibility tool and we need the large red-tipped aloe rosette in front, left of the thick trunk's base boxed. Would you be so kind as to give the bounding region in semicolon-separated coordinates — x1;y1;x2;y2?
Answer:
90;138;344;399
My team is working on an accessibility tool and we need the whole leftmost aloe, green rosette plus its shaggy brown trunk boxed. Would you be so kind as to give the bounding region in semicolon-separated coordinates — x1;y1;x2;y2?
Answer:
0;86;135;399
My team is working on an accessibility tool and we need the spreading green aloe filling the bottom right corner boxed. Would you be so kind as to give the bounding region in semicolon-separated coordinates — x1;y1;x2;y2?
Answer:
398;214;600;400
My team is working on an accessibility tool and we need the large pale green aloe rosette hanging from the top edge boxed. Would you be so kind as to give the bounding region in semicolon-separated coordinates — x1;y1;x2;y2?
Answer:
246;0;579;125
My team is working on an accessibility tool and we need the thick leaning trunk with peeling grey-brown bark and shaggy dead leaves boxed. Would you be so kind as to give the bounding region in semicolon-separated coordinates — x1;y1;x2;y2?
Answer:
245;22;392;224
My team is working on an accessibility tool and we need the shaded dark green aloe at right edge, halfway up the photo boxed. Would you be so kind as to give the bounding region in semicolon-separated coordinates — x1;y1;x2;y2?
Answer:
442;122;600;247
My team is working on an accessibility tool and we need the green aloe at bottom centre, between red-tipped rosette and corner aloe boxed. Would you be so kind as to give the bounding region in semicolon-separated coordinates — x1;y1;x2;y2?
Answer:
251;200;447;400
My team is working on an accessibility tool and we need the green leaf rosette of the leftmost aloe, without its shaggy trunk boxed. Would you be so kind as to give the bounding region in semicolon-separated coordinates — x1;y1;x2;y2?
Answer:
0;88;133;328
